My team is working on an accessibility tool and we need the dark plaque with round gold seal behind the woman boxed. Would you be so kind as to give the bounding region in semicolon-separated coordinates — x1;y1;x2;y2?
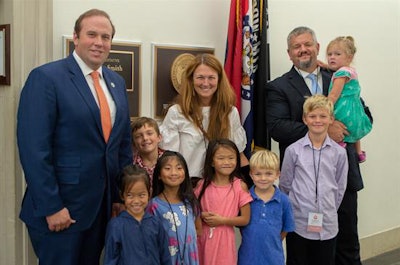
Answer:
153;43;214;119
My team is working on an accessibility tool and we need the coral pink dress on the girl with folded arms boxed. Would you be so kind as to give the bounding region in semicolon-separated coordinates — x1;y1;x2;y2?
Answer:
195;178;253;265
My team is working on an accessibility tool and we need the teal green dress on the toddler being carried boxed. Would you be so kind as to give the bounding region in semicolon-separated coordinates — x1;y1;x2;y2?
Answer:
329;67;372;143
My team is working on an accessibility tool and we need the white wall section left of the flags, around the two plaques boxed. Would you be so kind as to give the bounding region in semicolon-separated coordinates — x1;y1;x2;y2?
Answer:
54;0;229;116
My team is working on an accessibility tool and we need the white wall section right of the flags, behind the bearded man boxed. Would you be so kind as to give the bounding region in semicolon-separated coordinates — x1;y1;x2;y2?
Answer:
269;0;400;237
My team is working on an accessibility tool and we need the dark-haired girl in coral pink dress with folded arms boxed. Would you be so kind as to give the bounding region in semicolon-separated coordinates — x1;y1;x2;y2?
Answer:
195;139;252;265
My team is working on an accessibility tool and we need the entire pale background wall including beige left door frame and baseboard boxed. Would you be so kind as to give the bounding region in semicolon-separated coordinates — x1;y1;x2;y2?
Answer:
0;0;400;264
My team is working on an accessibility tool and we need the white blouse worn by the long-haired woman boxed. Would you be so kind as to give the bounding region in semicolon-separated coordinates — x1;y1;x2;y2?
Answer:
160;104;247;177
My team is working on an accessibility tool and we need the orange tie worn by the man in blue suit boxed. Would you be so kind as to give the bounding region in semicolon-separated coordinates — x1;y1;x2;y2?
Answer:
90;71;112;143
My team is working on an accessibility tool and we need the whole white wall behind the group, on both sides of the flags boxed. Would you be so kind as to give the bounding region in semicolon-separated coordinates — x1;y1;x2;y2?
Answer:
53;0;400;249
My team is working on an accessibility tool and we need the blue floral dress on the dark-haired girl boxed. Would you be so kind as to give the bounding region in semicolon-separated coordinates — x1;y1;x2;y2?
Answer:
148;197;199;265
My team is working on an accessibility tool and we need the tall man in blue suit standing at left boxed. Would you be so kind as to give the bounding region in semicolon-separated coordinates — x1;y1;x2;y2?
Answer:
17;9;132;265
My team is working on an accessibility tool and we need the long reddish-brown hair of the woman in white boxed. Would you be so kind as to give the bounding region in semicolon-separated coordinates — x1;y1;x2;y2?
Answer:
176;53;236;140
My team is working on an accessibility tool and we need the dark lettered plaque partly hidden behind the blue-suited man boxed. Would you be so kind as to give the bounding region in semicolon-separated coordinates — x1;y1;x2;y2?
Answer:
63;36;141;119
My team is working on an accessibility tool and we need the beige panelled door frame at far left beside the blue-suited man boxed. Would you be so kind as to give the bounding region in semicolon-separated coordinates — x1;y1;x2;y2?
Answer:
0;0;53;265
